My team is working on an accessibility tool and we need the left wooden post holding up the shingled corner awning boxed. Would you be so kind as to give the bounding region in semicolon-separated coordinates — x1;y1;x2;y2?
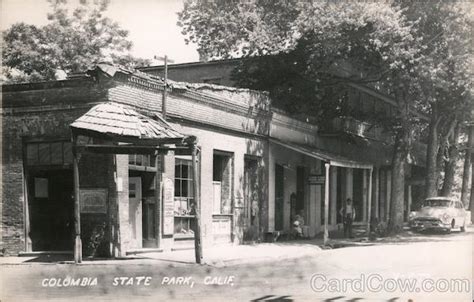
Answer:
72;134;82;263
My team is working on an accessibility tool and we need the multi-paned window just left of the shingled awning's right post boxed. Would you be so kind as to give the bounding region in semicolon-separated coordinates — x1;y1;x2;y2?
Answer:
174;158;194;216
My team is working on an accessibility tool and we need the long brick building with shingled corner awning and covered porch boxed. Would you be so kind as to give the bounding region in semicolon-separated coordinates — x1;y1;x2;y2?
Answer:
1;64;422;256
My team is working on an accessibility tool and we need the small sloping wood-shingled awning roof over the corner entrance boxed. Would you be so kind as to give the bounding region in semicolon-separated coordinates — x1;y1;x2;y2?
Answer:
70;102;186;143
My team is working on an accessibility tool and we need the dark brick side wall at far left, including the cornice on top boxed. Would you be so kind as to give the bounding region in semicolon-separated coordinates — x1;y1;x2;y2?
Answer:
0;80;105;255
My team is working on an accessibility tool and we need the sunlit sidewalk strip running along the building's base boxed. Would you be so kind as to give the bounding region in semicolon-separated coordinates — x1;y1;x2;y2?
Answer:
0;227;462;267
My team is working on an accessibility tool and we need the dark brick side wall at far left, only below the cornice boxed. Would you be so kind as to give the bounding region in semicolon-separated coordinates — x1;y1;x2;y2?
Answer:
0;105;90;254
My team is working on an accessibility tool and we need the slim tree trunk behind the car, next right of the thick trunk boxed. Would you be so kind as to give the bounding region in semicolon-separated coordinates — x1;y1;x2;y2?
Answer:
425;104;440;198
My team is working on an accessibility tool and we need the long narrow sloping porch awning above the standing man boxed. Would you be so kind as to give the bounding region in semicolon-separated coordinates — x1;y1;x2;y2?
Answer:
270;139;374;169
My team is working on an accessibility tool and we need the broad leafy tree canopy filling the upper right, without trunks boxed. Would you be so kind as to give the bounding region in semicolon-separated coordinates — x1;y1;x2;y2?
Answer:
178;0;472;129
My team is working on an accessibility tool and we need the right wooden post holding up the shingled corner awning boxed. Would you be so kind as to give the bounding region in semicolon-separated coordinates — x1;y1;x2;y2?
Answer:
191;142;203;264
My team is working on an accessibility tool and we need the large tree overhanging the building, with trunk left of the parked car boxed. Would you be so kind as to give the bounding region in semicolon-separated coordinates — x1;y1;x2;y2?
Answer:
179;0;422;234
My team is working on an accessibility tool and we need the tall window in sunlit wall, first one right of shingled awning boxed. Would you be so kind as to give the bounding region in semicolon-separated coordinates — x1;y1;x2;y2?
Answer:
212;152;231;214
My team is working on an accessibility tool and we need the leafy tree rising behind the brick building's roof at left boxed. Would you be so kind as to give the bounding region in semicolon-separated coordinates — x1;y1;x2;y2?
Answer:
2;0;149;82
